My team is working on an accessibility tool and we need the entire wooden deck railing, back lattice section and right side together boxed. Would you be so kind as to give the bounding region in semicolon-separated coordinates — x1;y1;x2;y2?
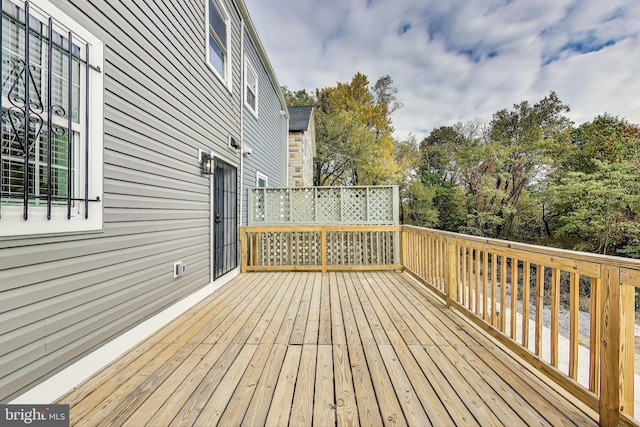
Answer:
241;225;640;425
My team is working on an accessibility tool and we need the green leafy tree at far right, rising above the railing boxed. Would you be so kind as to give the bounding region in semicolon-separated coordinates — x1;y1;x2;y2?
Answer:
546;114;640;257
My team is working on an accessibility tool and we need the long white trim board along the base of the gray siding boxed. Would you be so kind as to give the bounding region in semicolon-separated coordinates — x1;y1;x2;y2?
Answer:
9;268;240;404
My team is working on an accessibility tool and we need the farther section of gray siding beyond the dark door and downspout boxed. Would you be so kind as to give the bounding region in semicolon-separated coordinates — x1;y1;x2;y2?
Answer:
242;28;288;225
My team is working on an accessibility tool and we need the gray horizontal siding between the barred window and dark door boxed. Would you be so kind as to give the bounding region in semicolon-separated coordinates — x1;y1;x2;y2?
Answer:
0;0;245;402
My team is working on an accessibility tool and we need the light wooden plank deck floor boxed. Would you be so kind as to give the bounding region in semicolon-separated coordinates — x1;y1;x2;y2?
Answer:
57;272;596;426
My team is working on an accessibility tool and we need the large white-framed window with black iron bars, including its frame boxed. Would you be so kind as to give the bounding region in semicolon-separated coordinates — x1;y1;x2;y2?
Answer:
0;0;103;236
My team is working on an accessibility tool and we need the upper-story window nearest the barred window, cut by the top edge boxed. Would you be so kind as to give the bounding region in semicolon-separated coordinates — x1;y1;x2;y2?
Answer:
207;0;231;87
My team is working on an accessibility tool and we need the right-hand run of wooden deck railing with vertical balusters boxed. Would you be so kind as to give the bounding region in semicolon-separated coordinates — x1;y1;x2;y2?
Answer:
401;226;640;425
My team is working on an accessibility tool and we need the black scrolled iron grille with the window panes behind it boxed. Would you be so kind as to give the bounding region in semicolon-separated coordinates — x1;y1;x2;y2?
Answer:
0;0;102;224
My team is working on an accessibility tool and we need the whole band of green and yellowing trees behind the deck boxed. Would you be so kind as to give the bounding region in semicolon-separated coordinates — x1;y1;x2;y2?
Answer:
284;78;640;258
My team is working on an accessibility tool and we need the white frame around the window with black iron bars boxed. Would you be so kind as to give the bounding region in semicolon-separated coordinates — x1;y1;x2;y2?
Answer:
0;0;104;237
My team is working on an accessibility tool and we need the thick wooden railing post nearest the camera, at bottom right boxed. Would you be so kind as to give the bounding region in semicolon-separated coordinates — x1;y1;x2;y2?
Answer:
599;265;634;426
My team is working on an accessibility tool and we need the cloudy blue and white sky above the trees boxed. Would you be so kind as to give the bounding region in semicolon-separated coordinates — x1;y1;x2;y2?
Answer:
245;0;640;140
